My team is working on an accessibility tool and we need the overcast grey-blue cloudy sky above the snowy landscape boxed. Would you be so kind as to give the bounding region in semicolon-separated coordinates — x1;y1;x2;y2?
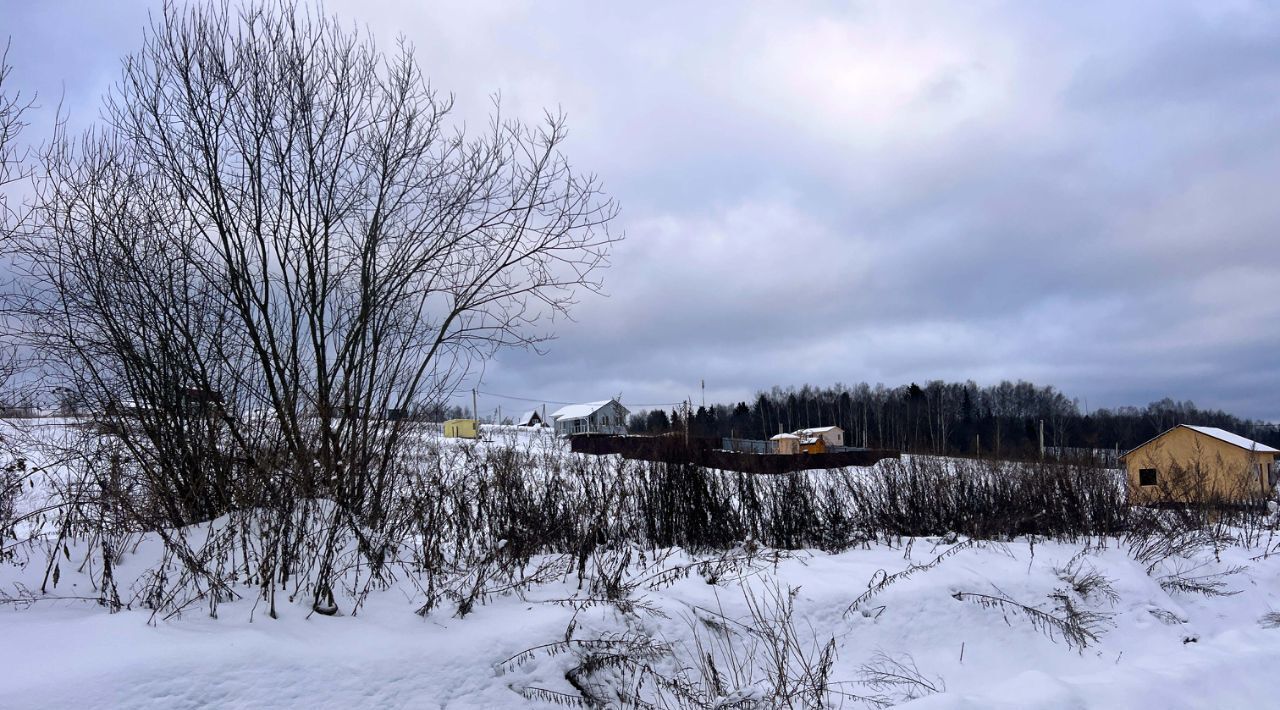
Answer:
0;0;1280;421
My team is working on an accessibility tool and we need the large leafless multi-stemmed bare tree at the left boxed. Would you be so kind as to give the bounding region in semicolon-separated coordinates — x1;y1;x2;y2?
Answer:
11;1;616;611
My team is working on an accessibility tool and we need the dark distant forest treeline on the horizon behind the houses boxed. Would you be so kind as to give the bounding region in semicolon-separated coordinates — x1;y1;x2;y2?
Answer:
628;380;1280;457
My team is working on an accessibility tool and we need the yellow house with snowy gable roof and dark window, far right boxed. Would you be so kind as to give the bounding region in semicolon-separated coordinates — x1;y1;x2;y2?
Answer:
1120;423;1280;503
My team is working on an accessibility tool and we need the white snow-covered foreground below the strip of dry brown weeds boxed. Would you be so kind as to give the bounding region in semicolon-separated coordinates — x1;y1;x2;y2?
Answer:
0;419;1280;709
